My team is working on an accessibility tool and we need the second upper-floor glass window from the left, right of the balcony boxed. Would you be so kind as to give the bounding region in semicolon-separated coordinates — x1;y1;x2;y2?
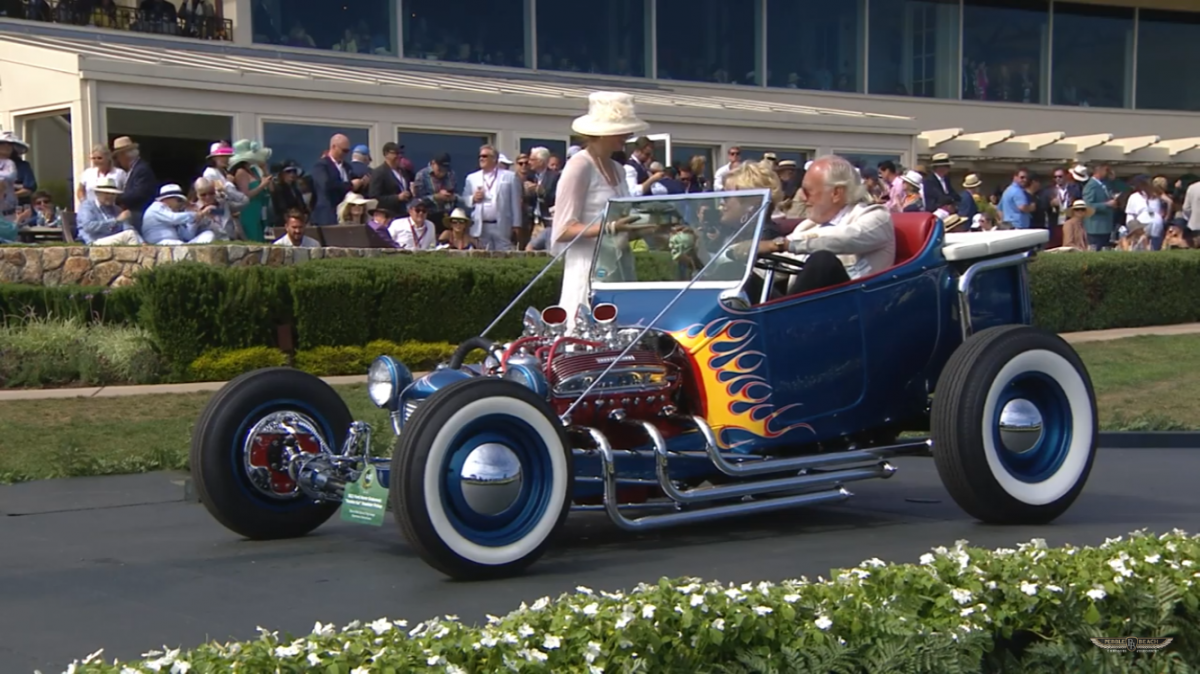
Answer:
404;0;530;67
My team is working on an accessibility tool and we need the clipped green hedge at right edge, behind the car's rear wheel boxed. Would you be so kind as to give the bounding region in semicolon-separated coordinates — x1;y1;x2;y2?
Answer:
1030;251;1200;332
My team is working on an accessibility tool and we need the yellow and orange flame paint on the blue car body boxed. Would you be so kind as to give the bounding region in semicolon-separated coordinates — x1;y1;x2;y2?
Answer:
671;318;812;449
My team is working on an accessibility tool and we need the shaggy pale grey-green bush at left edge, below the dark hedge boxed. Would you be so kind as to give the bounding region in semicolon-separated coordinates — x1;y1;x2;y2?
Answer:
0;318;164;387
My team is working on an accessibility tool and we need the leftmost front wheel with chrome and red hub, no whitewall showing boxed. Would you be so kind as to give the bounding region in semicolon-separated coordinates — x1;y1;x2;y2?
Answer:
190;367;353;540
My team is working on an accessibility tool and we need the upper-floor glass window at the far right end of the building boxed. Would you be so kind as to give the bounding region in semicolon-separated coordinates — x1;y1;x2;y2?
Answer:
1138;10;1200;112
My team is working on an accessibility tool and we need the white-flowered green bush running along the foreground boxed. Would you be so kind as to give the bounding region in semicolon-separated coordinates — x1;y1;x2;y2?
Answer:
63;530;1200;674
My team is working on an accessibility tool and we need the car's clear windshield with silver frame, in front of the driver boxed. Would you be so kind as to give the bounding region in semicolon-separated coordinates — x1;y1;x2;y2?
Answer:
590;189;770;287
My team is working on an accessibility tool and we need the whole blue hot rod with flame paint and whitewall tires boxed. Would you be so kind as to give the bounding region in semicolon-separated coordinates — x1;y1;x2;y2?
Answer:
192;191;1097;578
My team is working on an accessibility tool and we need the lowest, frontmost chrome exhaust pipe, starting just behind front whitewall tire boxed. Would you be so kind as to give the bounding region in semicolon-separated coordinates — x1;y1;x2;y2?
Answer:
582;427;852;531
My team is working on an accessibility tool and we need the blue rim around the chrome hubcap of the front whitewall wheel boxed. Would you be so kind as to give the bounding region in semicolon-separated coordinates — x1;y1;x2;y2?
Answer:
440;414;554;547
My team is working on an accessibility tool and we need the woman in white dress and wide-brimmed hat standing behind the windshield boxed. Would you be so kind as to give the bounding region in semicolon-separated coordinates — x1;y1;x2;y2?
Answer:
551;91;649;330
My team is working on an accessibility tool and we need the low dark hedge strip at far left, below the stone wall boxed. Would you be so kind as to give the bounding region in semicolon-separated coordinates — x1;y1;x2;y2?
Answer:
0;283;139;325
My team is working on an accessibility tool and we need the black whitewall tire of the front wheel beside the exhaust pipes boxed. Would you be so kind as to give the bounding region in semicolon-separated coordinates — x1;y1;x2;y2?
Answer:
391;379;574;578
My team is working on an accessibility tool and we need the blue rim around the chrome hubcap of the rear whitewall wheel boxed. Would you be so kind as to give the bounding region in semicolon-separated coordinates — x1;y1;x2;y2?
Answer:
991;372;1073;485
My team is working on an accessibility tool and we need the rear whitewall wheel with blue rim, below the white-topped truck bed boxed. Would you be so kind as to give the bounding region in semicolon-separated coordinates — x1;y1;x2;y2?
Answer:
930;325;1099;524
